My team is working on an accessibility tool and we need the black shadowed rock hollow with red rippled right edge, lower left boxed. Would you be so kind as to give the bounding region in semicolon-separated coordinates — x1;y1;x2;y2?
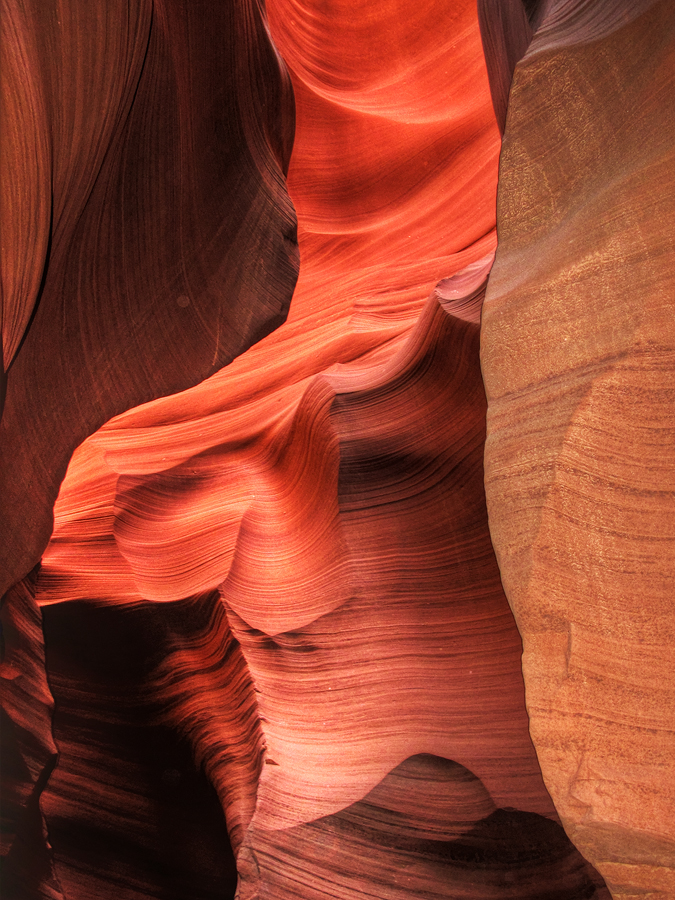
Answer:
41;596;243;900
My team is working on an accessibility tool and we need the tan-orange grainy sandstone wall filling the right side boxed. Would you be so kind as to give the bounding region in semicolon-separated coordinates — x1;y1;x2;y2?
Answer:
482;2;675;898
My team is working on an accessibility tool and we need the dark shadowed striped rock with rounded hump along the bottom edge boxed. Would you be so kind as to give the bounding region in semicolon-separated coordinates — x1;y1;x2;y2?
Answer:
251;754;598;900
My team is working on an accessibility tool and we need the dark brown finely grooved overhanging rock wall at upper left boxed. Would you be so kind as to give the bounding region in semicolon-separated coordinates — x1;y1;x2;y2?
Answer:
0;0;297;595
